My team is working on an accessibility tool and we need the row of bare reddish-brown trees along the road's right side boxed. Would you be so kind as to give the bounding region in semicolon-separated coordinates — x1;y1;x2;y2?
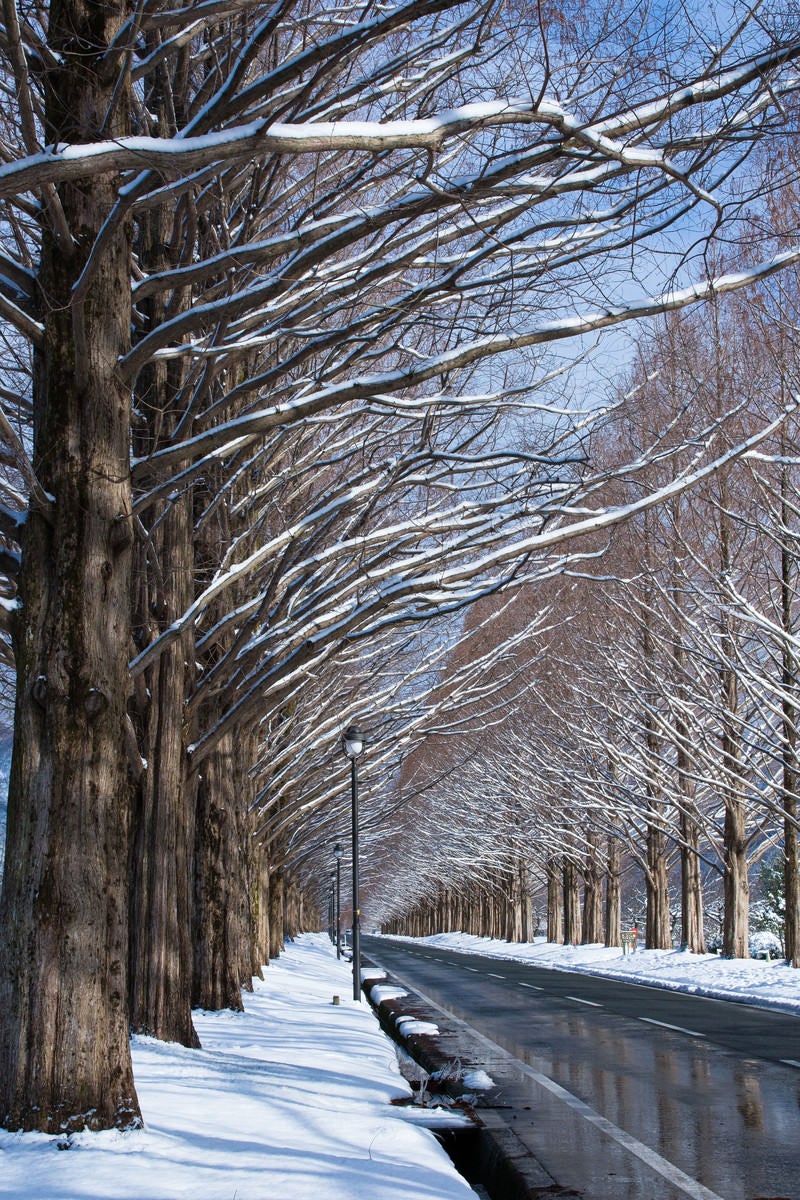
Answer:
377;277;800;966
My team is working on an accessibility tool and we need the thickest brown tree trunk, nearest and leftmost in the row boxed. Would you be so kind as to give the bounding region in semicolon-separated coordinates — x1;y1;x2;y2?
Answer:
0;0;140;1132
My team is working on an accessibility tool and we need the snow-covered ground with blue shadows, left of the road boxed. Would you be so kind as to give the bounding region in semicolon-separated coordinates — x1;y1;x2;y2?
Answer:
0;934;475;1200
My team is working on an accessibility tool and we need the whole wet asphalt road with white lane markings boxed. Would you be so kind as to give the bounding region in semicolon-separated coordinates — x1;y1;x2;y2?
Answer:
363;937;800;1200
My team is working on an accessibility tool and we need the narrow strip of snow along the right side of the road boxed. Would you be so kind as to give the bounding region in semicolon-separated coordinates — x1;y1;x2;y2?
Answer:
379;934;800;1013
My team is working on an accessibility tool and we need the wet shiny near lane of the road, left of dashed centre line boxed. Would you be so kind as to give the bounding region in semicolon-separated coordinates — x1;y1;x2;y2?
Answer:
362;943;800;1200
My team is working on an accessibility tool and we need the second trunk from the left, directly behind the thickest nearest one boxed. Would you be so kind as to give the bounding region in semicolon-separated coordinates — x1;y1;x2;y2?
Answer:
130;39;198;1045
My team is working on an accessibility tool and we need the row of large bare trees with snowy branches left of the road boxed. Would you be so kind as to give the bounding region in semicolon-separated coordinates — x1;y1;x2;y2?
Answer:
0;0;800;1132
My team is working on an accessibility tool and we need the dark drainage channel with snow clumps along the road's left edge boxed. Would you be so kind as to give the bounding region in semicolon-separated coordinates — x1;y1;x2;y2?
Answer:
362;959;581;1200
